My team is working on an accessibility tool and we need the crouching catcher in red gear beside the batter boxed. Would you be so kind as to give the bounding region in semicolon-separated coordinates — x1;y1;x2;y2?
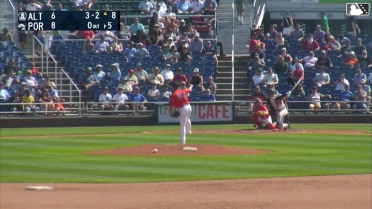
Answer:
251;98;278;131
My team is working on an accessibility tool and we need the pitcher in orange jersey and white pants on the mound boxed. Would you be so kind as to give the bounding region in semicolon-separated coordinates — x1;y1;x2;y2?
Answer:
168;81;193;144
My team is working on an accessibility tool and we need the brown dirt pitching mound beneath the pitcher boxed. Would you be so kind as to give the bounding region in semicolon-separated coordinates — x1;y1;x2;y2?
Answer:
89;144;269;156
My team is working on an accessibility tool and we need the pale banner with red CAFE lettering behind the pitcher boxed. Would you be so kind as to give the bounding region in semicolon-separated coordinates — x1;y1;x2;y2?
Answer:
157;102;234;123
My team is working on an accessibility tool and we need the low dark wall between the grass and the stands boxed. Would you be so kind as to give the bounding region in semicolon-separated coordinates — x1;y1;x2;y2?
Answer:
0;114;372;128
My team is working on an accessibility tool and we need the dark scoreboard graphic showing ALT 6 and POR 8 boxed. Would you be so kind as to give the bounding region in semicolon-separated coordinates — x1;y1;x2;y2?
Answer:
18;11;120;31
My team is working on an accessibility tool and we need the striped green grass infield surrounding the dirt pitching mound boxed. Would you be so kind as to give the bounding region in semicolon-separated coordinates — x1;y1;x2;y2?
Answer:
0;124;372;183
